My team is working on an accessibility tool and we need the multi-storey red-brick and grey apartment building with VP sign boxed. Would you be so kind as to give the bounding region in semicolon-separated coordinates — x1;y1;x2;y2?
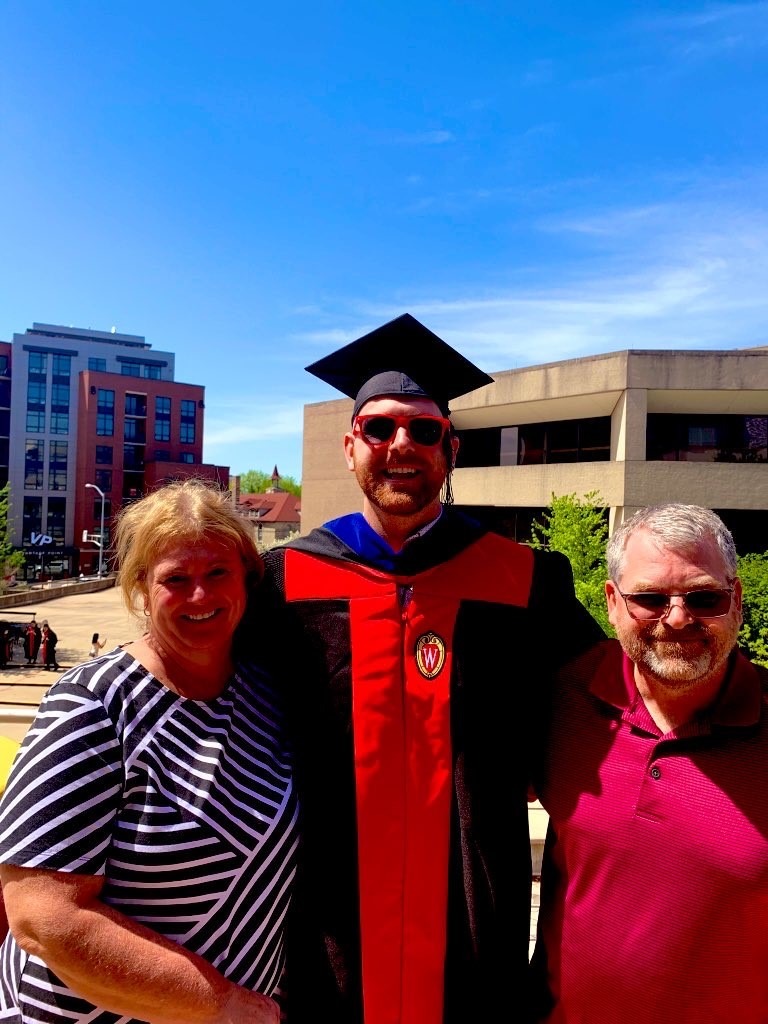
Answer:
6;324;229;580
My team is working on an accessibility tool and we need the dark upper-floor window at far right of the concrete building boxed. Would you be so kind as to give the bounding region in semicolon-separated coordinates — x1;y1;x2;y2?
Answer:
645;413;768;463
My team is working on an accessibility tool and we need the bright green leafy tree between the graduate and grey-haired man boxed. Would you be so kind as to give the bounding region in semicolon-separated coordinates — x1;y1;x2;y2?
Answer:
530;490;615;636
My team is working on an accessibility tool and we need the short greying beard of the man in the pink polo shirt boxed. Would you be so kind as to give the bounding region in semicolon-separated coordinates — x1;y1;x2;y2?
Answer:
616;622;738;692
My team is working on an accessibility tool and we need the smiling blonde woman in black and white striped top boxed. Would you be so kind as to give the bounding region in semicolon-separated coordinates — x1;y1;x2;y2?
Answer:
0;480;298;1024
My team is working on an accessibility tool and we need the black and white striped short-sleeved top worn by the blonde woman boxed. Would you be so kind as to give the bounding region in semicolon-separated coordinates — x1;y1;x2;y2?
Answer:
0;650;298;1024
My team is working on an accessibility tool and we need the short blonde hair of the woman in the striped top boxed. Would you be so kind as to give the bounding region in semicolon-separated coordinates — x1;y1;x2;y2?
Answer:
114;478;264;615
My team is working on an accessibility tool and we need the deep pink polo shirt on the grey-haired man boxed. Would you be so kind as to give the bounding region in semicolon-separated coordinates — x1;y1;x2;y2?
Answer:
535;640;768;1024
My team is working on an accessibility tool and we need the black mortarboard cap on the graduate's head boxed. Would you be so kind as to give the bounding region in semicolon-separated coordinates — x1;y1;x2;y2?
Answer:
306;313;494;419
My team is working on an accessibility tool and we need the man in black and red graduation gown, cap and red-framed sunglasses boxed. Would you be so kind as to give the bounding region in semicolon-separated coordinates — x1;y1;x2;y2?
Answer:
264;314;602;1024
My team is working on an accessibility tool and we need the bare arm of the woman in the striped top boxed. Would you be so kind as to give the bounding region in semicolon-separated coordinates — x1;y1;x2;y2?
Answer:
0;864;280;1024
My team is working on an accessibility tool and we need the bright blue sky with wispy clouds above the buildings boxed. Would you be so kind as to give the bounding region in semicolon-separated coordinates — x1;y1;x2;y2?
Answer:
0;0;768;479
